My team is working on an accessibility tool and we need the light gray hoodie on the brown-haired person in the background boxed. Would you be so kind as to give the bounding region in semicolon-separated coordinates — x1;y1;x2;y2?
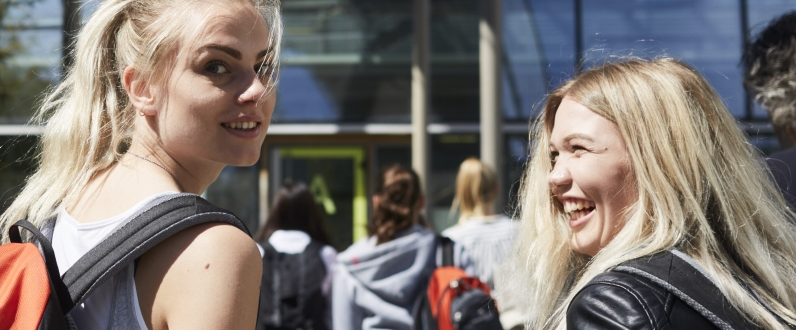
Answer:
332;226;473;330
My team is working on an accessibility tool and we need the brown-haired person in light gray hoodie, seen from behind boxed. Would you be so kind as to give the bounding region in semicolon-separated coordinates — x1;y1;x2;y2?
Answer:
332;165;472;330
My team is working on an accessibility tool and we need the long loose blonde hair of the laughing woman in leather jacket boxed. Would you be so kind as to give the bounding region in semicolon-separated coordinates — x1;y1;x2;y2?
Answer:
503;58;796;329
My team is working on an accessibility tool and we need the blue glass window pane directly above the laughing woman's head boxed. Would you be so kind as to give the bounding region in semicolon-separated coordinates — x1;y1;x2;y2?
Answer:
583;0;746;117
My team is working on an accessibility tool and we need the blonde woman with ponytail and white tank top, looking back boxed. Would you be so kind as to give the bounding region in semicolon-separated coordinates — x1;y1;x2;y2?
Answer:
0;0;282;330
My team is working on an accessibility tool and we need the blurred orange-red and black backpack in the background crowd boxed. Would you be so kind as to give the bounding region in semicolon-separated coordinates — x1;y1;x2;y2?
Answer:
412;236;503;330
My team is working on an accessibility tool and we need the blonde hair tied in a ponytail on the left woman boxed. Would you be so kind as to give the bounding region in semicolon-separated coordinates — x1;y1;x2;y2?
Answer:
0;0;282;236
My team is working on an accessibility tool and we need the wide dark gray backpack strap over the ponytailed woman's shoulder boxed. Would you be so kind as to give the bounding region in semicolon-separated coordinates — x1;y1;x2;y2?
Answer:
62;193;251;312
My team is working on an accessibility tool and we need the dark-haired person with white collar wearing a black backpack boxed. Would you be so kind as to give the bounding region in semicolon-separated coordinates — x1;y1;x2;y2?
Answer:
254;182;337;330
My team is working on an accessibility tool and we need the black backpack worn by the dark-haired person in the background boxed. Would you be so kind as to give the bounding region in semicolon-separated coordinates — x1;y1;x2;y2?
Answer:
256;240;328;330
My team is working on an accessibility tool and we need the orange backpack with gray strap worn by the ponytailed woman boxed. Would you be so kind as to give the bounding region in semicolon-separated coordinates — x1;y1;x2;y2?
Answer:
0;194;249;330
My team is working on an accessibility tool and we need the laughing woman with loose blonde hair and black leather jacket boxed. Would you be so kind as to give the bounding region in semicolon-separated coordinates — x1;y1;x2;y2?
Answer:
498;58;796;329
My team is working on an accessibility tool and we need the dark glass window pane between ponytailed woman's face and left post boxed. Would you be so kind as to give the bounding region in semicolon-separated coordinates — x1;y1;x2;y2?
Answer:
274;0;412;123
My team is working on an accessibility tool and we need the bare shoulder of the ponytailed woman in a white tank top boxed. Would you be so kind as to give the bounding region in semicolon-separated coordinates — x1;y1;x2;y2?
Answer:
136;224;262;329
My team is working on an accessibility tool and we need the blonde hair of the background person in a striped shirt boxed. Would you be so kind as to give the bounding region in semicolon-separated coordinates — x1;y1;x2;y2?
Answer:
451;157;498;224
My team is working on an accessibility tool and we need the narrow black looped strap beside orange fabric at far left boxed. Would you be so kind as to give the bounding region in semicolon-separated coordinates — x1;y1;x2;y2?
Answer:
8;220;71;316
